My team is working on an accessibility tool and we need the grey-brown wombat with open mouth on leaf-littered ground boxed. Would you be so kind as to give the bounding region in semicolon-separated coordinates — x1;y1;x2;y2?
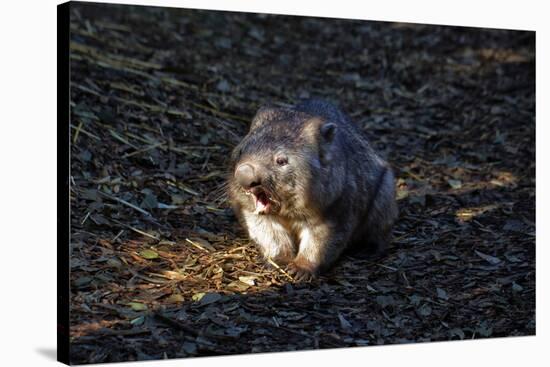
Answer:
228;100;397;280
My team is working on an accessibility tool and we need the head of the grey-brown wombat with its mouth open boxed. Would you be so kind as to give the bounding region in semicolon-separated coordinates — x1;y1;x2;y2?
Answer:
229;107;337;216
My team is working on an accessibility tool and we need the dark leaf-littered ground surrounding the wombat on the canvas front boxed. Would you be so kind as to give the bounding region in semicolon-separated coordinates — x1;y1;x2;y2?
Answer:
70;4;535;363
